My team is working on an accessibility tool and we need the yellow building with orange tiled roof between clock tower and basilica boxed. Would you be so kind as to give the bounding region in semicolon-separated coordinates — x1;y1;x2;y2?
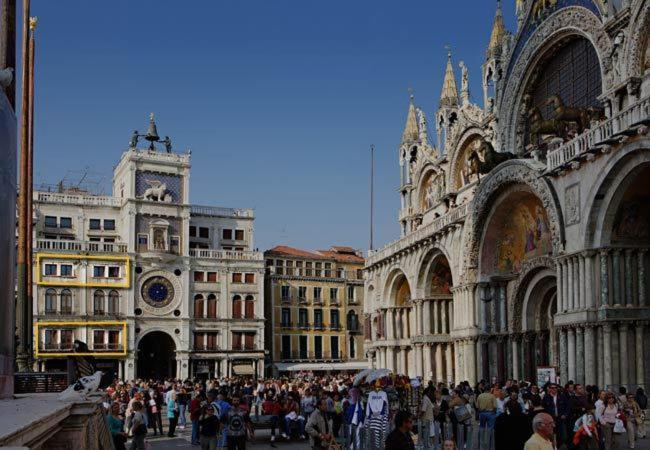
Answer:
264;246;367;374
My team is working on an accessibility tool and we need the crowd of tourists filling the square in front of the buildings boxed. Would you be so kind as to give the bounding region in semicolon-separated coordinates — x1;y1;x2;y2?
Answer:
100;375;647;450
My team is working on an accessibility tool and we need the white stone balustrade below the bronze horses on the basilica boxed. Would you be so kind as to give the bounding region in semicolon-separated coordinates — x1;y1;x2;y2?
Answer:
546;97;650;172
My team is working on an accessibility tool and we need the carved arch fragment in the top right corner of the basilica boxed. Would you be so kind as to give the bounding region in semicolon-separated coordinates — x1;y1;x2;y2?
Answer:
625;1;650;78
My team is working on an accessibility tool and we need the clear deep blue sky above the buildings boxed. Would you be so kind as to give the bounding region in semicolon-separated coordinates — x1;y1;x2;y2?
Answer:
22;0;514;249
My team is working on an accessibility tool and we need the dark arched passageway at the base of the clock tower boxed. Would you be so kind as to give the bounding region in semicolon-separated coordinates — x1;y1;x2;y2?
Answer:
137;331;176;379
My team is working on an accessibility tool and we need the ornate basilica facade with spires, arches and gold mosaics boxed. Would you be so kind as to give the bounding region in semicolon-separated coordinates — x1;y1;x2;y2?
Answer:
364;0;650;388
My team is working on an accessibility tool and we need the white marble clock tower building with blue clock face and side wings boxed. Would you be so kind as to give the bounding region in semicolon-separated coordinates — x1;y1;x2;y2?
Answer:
34;140;264;379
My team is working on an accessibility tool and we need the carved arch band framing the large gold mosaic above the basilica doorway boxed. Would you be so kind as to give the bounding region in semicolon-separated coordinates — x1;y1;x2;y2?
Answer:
463;159;564;282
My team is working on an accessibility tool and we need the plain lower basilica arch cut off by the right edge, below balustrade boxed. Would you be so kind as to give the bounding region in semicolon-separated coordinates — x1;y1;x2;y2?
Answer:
581;139;650;248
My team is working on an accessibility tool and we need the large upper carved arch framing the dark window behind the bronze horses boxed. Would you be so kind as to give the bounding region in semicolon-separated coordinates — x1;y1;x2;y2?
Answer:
498;6;614;153
